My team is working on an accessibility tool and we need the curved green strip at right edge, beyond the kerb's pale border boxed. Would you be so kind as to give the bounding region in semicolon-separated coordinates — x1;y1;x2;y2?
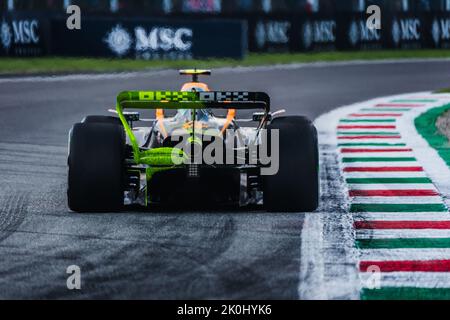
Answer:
415;104;450;167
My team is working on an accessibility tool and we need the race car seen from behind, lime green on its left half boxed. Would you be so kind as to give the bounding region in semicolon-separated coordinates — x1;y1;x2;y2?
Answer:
67;70;319;212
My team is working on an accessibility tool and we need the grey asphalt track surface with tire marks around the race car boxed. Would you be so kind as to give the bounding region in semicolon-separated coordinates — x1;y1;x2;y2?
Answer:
0;61;450;299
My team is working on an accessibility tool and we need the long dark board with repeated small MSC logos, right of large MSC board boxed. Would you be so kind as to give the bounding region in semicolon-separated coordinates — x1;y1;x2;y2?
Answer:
248;13;442;52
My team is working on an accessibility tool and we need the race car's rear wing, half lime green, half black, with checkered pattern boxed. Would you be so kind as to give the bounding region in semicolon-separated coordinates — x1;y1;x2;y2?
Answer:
117;91;270;114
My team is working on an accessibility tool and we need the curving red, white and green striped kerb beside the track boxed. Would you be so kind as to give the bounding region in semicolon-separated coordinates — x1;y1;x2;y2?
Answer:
337;97;450;299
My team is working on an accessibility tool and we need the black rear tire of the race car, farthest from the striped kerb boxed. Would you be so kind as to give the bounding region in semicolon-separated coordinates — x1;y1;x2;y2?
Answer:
67;123;125;212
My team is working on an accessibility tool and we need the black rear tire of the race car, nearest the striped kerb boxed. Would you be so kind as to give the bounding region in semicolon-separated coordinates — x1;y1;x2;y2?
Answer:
263;116;319;212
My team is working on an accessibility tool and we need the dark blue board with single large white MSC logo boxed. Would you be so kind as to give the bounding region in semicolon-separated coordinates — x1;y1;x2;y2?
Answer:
51;17;247;59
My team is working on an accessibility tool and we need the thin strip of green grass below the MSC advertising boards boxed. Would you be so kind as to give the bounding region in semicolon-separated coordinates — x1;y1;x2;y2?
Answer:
0;50;450;75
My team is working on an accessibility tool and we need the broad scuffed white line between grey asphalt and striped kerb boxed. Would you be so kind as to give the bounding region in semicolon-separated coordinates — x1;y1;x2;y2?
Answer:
298;98;360;299
